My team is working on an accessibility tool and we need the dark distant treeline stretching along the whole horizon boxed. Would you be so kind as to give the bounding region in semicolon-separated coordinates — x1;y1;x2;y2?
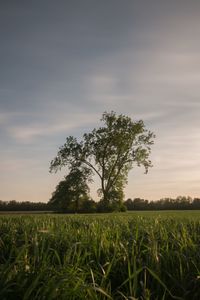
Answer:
0;196;200;213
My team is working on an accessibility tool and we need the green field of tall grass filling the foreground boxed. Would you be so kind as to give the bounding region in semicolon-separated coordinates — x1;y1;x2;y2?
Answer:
0;211;200;300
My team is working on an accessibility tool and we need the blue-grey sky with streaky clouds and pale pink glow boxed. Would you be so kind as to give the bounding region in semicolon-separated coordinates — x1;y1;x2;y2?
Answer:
0;0;200;202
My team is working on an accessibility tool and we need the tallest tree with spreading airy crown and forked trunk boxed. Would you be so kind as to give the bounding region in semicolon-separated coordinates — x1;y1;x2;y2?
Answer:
50;112;154;203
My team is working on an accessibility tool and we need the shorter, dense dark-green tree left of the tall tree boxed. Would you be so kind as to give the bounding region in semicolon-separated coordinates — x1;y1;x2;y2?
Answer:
49;168;90;212
